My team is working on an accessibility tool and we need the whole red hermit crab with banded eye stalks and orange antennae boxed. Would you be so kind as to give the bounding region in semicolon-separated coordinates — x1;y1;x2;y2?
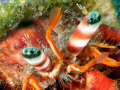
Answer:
0;0;120;90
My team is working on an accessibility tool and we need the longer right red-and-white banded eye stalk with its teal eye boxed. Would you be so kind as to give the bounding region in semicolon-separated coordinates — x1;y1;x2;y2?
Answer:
67;11;101;56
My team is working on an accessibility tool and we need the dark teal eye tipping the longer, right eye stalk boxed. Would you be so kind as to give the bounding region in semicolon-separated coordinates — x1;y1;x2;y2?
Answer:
87;11;101;28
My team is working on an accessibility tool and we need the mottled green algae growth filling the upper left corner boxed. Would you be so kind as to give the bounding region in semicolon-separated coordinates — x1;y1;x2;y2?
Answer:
0;0;74;37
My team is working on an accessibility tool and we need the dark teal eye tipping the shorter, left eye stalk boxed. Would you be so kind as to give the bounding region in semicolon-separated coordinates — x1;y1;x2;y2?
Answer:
22;47;41;59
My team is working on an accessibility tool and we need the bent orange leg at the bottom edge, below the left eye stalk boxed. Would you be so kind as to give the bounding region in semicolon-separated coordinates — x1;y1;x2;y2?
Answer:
22;75;44;90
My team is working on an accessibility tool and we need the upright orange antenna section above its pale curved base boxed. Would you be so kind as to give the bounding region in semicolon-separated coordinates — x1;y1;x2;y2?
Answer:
46;7;62;59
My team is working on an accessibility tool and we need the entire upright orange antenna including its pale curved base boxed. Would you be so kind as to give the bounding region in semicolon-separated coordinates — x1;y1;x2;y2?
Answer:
39;7;62;78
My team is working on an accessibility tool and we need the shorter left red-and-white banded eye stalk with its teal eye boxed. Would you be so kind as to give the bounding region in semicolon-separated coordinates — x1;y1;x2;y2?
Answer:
22;47;51;71
